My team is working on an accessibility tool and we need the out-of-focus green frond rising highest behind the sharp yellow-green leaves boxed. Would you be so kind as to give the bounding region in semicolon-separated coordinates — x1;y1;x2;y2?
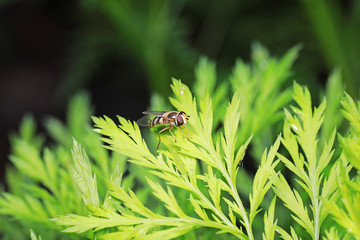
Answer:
229;44;300;160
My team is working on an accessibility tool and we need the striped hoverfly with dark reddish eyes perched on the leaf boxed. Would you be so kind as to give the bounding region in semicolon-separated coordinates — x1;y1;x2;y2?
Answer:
136;111;190;151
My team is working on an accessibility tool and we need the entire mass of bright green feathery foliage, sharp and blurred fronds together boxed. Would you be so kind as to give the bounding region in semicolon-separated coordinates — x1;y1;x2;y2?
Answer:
0;45;360;240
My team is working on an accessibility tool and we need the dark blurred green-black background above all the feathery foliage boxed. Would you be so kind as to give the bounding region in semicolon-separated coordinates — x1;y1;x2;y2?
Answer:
0;0;360;180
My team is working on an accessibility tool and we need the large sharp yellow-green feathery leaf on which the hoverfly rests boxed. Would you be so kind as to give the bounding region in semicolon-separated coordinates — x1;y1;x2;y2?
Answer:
54;80;280;239
